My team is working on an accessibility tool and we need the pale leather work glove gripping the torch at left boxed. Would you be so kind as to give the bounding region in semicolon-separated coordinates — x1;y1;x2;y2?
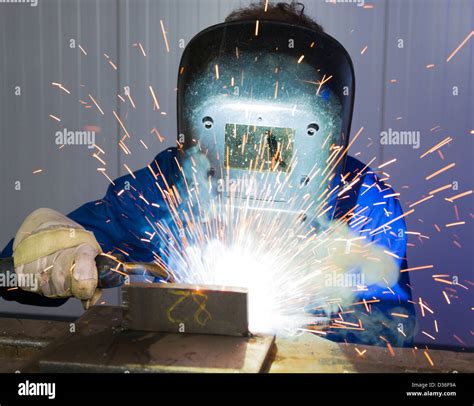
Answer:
13;209;102;309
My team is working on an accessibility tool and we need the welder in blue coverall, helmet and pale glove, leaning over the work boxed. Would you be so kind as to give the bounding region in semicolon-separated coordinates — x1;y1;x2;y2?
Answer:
1;3;414;346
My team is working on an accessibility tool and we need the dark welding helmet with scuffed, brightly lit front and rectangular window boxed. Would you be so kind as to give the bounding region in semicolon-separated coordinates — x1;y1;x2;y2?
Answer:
177;20;355;225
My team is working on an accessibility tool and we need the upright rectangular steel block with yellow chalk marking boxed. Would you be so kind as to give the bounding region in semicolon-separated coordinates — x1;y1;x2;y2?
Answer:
122;283;248;336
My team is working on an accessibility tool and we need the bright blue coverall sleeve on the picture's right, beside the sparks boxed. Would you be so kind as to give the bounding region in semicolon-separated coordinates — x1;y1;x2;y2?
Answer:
329;157;415;346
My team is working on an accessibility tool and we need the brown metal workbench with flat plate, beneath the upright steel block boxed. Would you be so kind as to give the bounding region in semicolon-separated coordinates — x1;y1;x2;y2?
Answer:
0;306;474;373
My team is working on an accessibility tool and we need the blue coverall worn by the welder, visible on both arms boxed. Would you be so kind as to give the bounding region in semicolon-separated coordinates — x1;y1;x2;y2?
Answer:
0;148;414;346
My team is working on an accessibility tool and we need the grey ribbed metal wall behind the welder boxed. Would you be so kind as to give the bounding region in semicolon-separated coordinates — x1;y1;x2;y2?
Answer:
0;0;474;347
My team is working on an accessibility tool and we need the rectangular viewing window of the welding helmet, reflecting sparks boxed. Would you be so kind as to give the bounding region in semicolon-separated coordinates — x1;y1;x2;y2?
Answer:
224;124;295;172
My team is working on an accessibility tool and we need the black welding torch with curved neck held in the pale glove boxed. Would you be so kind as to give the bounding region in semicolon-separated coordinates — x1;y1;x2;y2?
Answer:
0;254;174;289
